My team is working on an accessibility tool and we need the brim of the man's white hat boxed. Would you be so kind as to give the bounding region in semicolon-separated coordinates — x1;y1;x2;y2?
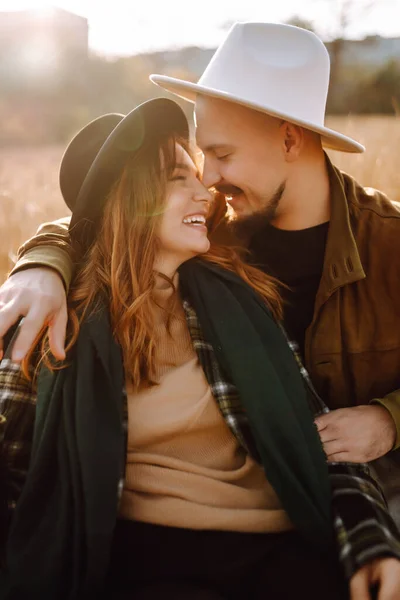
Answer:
150;74;365;153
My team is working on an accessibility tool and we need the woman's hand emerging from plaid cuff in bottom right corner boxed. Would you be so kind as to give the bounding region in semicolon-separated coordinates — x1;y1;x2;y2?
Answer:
350;558;400;600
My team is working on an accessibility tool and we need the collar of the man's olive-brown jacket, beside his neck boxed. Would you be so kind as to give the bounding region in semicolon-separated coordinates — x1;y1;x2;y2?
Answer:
317;155;365;303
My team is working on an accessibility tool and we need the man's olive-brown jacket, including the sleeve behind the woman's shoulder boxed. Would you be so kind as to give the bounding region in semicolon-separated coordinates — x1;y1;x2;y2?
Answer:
13;159;400;448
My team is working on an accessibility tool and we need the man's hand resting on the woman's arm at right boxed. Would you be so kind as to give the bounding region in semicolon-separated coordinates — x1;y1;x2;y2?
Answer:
315;405;400;462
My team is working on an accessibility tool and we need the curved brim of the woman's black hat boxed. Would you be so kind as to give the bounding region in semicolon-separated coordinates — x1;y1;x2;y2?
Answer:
70;98;190;231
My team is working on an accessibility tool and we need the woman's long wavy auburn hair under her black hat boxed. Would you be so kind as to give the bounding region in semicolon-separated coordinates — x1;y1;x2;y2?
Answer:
28;139;282;390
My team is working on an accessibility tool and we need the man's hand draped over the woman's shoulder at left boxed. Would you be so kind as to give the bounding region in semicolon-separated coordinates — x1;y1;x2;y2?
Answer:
0;267;67;362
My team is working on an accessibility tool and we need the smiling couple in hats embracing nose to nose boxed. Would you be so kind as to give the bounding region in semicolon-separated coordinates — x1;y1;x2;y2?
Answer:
0;23;400;600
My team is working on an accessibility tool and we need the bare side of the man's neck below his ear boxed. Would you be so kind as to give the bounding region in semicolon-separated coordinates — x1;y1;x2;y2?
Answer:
271;153;330;230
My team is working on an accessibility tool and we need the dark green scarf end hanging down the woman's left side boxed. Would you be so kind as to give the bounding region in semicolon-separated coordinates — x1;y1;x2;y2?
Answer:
0;310;125;600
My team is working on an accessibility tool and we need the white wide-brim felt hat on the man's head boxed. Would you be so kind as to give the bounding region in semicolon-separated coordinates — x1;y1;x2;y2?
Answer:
150;23;365;152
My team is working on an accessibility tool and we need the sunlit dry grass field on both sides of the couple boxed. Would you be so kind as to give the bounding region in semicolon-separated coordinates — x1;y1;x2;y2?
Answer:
0;117;400;281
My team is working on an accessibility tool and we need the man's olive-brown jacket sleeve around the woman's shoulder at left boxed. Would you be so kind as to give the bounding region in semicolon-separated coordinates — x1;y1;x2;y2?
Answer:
10;217;74;290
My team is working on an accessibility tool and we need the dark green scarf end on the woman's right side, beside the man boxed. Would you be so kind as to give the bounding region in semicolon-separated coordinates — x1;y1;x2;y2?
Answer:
180;259;333;548
